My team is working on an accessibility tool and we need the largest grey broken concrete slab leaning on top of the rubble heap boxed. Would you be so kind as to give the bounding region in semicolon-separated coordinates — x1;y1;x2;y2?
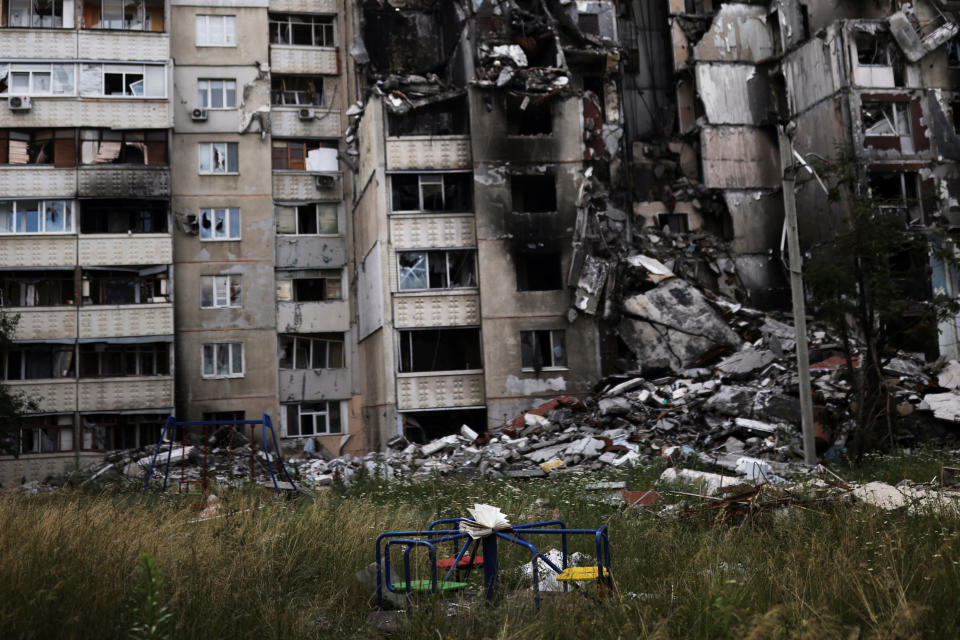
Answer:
620;279;741;370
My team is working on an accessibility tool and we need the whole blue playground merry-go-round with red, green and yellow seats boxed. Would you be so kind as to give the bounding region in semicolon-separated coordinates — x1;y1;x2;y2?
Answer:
376;518;613;609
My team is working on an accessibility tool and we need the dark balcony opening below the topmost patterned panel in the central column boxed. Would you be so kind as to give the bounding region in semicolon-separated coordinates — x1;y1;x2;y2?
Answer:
390;172;473;212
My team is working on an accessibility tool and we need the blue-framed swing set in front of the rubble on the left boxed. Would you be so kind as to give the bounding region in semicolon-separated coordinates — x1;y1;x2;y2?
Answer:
143;414;296;495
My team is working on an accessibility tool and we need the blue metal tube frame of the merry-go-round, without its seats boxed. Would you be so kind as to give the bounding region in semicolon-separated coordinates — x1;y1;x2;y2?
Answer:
376;518;613;609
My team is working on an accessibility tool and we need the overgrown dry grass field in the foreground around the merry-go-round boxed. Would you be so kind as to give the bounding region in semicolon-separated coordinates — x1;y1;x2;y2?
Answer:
0;452;960;640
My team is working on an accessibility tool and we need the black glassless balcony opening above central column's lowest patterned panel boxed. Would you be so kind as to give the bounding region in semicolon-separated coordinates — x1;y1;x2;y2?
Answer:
398;328;483;373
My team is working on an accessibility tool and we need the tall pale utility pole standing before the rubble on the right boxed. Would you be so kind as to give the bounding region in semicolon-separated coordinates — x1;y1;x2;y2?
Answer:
777;125;817;466
